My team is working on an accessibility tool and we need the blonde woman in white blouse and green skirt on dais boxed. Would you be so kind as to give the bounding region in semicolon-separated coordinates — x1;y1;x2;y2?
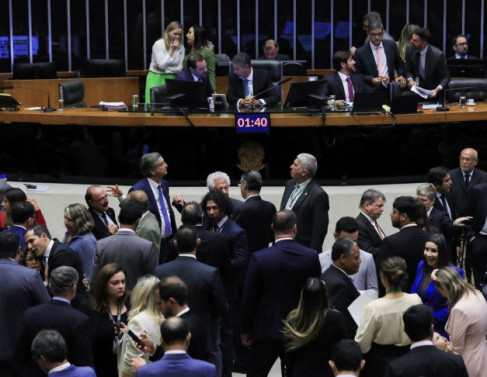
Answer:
145;21;184;103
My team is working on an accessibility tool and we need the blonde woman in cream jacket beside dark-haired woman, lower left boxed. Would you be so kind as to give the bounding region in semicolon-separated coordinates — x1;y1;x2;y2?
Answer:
117;275;164;377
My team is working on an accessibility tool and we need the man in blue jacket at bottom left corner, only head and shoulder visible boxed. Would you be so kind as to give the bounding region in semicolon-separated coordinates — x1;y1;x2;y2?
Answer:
31;330;96;377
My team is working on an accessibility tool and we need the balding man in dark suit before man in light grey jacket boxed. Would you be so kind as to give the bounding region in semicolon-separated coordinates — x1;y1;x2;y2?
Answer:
321;238;360;339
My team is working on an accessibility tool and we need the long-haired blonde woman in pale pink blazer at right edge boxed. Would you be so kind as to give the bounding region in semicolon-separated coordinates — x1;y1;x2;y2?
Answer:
431;267;487;377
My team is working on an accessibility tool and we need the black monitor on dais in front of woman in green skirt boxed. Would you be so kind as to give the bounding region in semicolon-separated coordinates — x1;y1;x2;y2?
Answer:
166;79;208;108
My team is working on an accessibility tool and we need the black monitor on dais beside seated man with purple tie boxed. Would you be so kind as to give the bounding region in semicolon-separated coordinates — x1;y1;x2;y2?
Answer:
284;80;328;107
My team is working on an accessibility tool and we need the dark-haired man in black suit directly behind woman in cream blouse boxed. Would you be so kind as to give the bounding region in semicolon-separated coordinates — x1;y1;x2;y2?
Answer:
377;196;429;295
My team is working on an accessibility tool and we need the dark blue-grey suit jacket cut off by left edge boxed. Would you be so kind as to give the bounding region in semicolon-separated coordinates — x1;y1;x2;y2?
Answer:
0;258;49;360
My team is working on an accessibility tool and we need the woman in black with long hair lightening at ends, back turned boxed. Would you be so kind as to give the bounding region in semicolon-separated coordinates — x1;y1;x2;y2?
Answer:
283;278;346;377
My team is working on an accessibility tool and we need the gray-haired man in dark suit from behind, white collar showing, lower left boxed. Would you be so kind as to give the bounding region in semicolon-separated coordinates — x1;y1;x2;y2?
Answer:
15;266;92;376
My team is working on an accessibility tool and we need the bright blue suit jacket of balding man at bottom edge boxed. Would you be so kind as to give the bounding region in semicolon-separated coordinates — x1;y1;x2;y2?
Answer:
136;353;216;377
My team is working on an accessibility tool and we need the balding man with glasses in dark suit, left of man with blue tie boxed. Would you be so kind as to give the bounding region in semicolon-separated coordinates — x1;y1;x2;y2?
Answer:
85;185;118;240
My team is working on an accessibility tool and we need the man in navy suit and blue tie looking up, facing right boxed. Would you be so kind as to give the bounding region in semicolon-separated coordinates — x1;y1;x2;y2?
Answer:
129;152;176;263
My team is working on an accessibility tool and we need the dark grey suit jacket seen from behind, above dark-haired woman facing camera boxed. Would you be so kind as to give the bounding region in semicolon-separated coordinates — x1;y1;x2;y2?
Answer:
91;229;157;291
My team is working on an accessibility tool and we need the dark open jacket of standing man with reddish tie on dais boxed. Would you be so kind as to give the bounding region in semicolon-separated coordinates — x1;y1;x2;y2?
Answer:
353;40;406;86
